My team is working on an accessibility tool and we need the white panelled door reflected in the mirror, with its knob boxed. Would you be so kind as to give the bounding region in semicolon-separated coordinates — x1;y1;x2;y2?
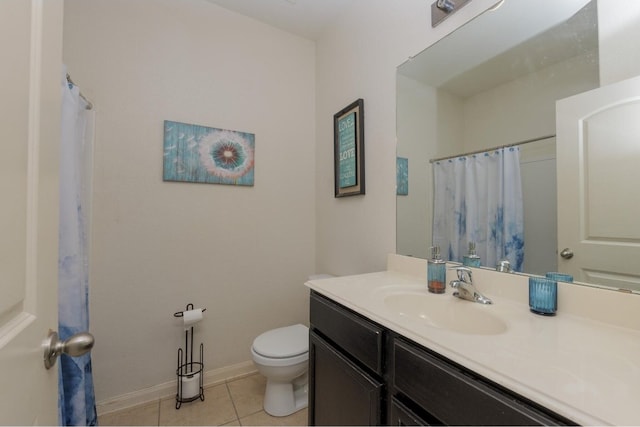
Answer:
556;77;640;290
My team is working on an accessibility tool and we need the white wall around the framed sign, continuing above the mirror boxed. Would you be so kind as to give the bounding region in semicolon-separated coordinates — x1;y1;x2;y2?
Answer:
316;0;495;275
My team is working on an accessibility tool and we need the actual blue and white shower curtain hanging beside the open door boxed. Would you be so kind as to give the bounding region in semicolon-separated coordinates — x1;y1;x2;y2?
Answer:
58;68;97;425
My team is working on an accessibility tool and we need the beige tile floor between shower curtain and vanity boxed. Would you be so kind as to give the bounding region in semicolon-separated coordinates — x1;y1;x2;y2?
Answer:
98;374;307;426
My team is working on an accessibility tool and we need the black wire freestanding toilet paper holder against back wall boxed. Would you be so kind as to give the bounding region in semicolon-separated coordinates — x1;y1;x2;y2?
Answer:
173;303;207;409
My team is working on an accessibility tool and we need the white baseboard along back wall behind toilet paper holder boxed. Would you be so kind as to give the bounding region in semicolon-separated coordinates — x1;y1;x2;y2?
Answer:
96;360;258;415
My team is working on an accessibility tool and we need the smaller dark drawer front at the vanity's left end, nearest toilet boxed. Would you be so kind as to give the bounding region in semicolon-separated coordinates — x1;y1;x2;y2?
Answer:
310;291;384;375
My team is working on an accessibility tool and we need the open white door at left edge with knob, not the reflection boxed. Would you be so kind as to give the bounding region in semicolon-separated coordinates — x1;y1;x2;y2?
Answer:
0;0;63;425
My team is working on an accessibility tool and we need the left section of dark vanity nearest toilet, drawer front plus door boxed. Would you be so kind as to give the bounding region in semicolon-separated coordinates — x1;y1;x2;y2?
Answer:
309;293;385;425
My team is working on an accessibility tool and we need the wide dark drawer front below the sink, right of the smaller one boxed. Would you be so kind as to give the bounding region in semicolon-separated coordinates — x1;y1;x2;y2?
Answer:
393;340;562;425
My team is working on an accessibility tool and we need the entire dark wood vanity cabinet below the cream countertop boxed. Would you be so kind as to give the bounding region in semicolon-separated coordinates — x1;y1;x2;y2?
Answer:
309;291;574;425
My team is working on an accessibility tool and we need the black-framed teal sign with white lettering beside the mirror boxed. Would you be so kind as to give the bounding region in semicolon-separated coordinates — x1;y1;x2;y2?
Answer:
333;99;365;197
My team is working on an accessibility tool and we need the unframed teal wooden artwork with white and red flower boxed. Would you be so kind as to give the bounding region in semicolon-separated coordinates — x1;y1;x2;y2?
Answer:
163;120;255;186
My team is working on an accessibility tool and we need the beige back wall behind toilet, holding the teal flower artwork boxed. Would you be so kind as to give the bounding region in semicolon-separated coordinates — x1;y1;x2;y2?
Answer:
64;0;315;401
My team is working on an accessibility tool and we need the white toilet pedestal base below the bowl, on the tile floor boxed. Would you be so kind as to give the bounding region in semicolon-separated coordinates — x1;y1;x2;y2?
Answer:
264;373;309;417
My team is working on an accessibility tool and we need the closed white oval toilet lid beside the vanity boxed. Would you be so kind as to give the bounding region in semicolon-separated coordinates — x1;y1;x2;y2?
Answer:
253;324;309;359
